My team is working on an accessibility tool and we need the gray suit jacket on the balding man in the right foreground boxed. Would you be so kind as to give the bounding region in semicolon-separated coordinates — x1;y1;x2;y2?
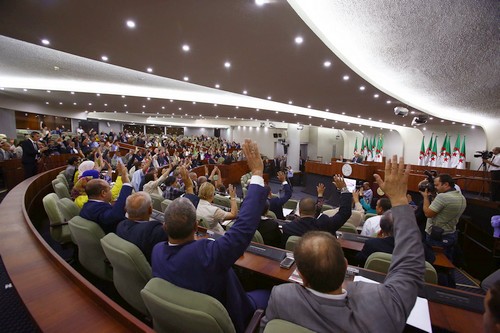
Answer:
261;205;425;333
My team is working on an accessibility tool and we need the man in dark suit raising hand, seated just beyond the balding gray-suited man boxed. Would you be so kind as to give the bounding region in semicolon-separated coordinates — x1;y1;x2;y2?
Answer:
282;175;352;246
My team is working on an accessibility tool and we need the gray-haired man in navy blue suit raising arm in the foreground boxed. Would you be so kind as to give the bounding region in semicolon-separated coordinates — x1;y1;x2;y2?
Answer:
152;140;269;332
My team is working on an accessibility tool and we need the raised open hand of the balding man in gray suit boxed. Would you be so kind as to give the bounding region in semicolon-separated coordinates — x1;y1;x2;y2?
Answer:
373;155;410;207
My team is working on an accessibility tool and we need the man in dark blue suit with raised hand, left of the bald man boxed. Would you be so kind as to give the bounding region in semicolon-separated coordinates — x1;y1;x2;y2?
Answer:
80;164;133;234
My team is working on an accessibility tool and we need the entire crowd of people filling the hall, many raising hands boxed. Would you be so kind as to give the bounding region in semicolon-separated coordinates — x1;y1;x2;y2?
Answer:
6;124;500;332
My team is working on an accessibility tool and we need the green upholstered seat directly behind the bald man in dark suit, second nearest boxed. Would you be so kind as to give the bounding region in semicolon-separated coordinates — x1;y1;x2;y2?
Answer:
101;233;153;315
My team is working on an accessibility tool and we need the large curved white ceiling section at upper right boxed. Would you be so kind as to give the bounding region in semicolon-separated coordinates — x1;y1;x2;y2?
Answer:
289;0;500;125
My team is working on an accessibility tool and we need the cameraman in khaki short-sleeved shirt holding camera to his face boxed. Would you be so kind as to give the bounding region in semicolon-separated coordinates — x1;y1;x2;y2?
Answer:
420;174;467;260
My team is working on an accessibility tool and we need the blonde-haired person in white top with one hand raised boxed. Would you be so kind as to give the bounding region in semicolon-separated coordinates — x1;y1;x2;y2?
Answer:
196;182;238;232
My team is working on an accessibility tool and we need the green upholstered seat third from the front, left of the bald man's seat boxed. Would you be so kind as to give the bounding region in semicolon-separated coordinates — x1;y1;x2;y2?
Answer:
68;216;113;281
